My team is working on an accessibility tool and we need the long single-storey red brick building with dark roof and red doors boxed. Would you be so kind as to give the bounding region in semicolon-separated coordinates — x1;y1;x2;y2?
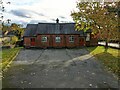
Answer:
23;19;97;48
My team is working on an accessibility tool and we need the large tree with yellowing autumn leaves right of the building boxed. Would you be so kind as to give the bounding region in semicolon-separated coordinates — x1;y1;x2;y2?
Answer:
71;2;119;47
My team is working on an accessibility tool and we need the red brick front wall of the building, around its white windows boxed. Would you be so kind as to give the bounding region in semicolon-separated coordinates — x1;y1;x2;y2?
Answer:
24;35;86;48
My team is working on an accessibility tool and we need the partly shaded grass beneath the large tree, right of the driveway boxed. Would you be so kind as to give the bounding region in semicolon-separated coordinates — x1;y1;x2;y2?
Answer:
87;46;120;75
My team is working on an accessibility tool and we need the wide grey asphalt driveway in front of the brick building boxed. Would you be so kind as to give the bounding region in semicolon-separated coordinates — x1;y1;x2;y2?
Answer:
2;49;118;88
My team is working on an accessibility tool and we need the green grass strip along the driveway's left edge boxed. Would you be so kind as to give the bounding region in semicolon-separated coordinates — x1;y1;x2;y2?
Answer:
0;47;21;69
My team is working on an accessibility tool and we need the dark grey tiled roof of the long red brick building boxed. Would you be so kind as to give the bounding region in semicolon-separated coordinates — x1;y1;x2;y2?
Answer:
24;23;91;36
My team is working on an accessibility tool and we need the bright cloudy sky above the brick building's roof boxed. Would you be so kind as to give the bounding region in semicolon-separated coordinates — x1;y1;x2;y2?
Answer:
3;0;77;26
